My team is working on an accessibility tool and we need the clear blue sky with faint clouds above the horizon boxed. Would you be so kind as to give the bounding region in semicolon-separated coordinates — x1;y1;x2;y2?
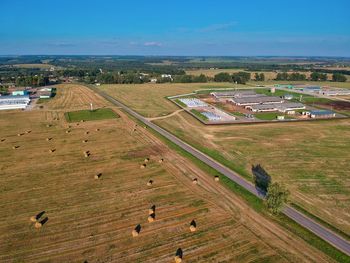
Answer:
0;0;350;57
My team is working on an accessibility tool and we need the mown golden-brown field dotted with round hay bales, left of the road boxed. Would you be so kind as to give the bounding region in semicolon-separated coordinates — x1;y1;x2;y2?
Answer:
0;85;331;262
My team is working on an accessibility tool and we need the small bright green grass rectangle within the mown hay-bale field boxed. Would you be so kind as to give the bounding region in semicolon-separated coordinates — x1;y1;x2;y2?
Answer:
64;108;119;122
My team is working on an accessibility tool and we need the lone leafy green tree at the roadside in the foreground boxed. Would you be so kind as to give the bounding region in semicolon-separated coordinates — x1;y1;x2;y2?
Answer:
265;183;290;214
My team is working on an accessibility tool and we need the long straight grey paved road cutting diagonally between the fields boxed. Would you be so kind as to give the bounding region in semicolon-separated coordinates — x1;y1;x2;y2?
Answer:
89;86;350;256
